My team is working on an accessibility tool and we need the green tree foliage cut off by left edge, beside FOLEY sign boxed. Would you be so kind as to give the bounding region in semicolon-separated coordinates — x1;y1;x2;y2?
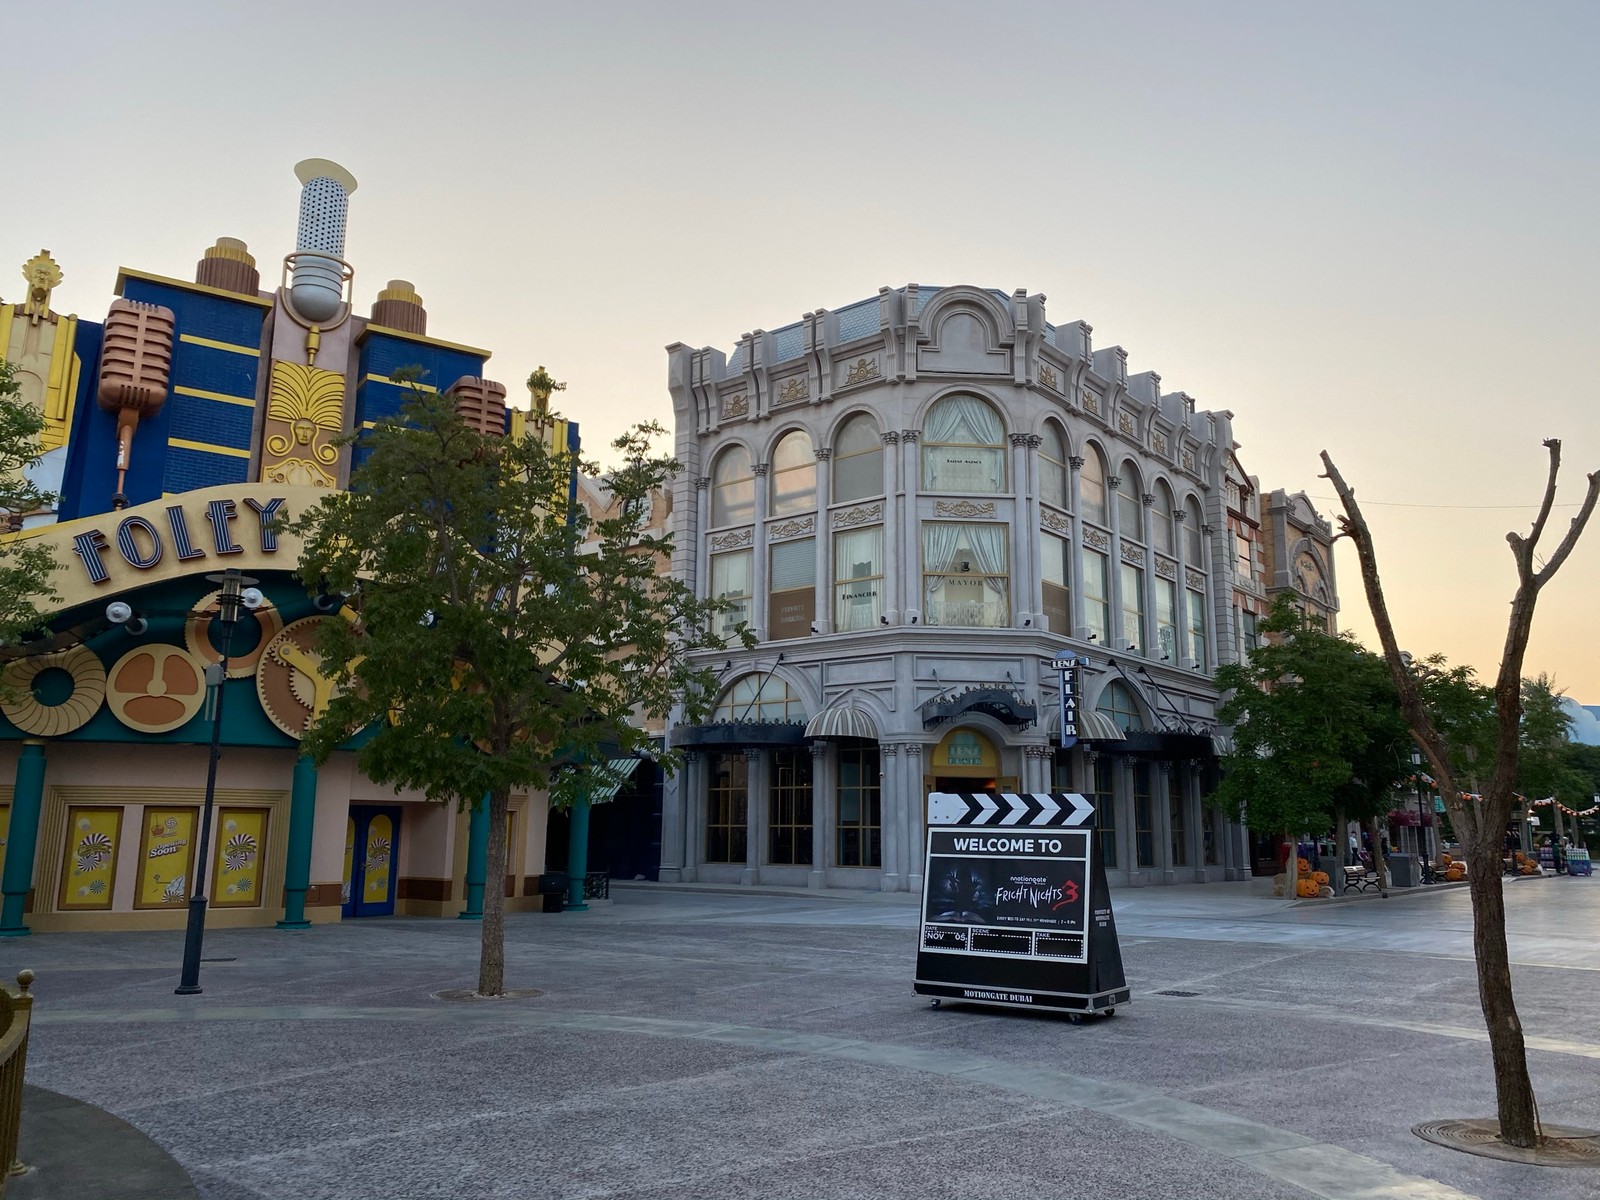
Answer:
0;358;56;645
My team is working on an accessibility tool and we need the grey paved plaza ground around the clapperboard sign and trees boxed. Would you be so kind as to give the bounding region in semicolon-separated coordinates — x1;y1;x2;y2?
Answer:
0;877;1600;1200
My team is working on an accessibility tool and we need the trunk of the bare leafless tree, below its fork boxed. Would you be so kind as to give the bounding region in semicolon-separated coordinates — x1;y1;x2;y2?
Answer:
1467;830;1539;1146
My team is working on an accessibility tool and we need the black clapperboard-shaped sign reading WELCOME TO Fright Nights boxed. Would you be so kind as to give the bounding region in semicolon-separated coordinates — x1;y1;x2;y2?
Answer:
915;792;1130;1014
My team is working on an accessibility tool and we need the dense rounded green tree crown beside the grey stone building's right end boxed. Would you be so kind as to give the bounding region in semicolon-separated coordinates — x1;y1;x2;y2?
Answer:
1216;595;1410;894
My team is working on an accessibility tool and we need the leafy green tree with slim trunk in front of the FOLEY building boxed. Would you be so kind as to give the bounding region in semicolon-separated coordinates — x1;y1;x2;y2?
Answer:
288;389;722;995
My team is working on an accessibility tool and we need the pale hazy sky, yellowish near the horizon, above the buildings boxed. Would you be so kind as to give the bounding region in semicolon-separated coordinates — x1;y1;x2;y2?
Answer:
9;0;1600;704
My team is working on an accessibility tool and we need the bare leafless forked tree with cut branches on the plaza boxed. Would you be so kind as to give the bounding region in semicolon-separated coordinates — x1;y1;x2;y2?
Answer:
1322;438;1600;1147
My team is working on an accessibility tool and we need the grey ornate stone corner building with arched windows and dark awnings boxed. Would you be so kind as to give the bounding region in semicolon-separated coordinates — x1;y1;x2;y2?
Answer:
661;285;1331;891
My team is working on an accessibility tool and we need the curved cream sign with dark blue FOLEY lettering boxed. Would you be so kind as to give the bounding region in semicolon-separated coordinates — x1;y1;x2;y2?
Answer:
21;483;328;608
